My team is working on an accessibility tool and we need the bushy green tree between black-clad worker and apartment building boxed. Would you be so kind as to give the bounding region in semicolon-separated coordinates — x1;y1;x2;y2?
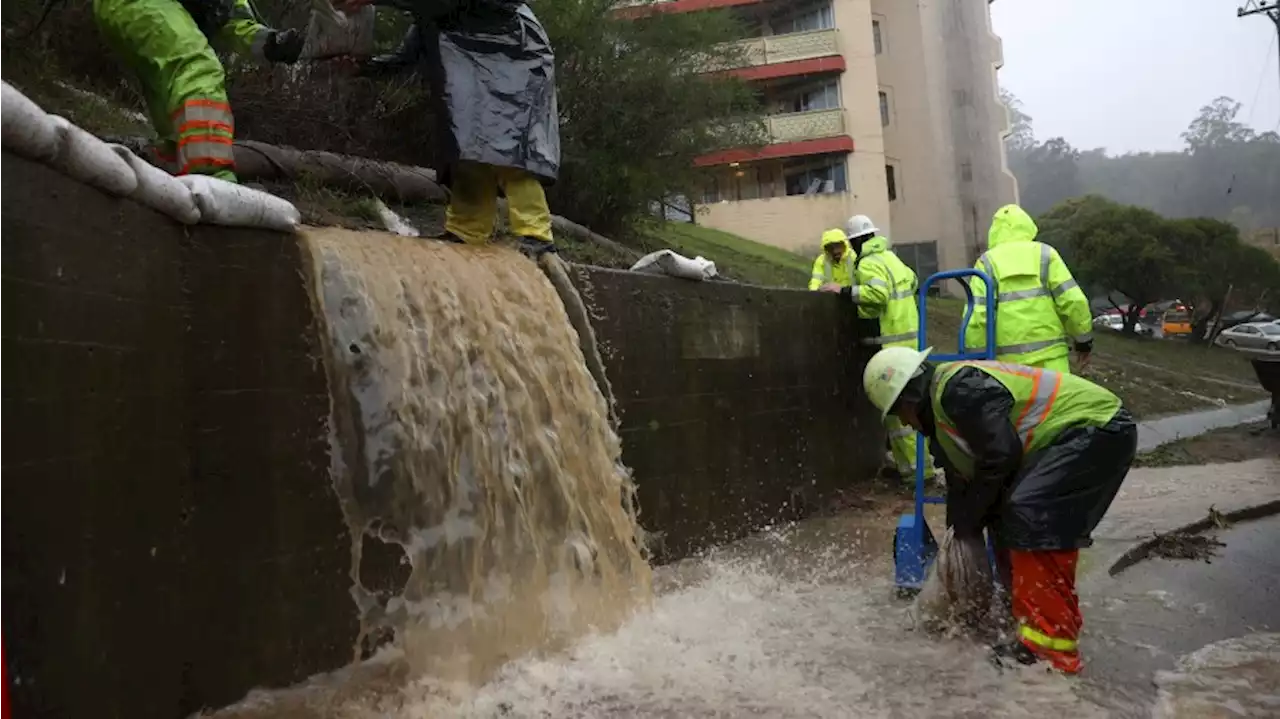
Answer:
538;0;765;233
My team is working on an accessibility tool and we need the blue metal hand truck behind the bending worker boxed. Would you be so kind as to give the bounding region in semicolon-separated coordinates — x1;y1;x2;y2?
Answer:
893;269;998;594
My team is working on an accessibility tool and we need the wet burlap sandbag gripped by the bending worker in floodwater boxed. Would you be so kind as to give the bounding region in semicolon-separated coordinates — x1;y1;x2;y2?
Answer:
911;528;993;632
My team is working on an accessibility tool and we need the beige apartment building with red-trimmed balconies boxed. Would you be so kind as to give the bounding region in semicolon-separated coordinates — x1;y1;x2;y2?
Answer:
624;0;1018;273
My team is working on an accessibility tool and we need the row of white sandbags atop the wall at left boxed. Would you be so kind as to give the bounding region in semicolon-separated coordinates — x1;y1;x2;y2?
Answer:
0;81;301;232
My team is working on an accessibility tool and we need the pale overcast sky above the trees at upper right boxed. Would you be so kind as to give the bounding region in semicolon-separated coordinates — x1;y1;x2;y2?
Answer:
991;0;1280;154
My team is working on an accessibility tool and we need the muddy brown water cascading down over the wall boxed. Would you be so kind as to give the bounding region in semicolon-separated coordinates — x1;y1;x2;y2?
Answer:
303;229;650;683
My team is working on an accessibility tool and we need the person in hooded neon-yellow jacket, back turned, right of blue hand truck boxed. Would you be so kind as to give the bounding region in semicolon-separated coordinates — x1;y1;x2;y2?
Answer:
965;205;1093;372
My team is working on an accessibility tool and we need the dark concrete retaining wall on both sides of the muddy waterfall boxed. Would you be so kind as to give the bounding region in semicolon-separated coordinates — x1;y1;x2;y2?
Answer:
0;152;882;719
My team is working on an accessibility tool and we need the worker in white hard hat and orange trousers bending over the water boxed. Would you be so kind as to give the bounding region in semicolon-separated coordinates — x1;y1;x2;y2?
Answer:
863;347;1138;674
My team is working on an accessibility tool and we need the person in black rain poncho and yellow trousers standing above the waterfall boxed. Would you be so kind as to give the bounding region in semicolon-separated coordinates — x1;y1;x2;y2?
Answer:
344;0;561;258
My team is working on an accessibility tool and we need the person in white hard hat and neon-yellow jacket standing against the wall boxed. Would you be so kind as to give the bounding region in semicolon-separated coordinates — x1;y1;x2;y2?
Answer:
810;215;937;481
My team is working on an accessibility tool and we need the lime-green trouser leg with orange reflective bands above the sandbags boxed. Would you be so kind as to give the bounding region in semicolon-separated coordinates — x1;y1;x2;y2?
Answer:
93;0;236;182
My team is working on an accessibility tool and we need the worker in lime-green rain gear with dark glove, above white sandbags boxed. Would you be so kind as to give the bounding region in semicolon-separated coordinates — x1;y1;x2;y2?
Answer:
93;0;305;182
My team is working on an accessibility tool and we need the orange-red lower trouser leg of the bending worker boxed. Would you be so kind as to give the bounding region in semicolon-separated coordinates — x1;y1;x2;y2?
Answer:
1009;549;1084;674
